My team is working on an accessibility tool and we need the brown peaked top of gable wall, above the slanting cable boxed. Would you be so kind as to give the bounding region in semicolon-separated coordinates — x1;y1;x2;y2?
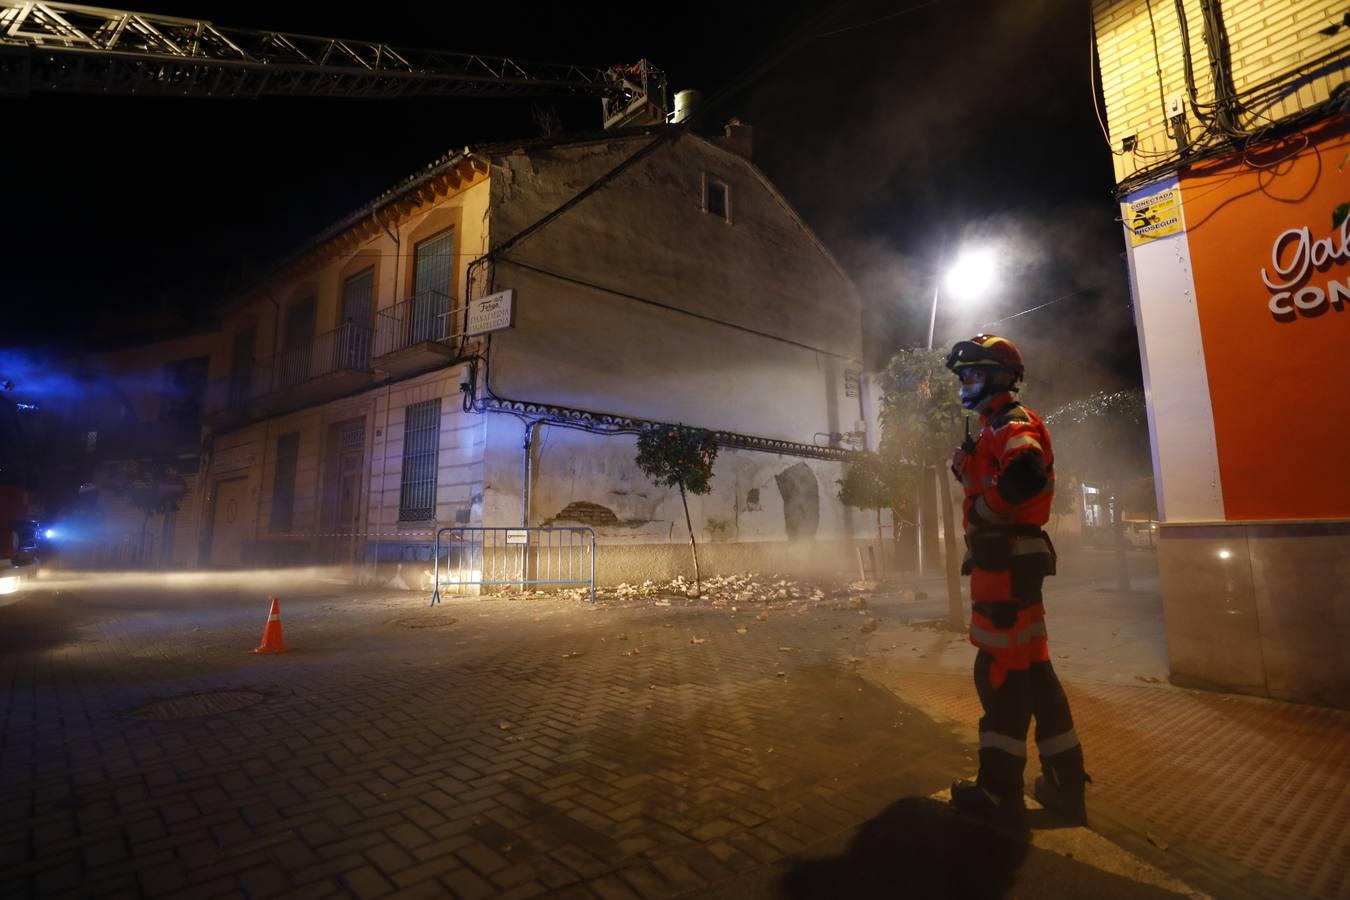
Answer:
490;135;861;358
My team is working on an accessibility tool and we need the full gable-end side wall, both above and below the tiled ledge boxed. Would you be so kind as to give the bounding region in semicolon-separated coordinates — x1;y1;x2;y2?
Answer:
483;134;863;582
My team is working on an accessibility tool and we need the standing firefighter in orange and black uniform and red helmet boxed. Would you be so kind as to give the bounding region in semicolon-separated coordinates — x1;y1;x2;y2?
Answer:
946;335;1091;827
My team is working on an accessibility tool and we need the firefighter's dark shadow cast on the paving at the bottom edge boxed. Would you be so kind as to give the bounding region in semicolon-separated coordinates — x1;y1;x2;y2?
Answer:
779;797;1030;900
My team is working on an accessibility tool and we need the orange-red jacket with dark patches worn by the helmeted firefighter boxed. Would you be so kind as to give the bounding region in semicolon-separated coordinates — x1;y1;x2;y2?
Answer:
957;393;1054;534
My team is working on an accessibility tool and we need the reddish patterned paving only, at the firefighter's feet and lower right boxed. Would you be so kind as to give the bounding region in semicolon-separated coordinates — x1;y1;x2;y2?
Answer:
868;660;1350;899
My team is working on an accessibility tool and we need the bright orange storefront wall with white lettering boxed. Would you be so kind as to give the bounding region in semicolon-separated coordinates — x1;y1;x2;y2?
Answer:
1181;120;1350;521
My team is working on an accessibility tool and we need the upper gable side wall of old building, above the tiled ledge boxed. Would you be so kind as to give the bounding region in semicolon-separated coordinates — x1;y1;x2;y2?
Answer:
490;135;861;444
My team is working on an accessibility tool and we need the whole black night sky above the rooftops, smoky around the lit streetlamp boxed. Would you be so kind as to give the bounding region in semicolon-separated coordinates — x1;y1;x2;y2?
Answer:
0;0;1138;399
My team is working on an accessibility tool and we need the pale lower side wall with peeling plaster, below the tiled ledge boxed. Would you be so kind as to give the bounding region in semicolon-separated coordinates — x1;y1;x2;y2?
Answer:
483;416;869;583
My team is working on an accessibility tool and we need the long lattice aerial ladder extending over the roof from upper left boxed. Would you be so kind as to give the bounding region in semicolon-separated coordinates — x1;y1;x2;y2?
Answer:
0;0;668;130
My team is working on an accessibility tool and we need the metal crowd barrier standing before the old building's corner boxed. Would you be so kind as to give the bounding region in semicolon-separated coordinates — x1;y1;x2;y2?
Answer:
431;525;595;606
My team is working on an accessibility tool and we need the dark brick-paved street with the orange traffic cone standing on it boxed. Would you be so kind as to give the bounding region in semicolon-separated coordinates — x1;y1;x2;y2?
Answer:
0;580;1252;897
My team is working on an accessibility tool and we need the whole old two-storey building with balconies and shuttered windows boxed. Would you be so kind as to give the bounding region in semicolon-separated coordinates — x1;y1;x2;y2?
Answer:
81;125;872;588
